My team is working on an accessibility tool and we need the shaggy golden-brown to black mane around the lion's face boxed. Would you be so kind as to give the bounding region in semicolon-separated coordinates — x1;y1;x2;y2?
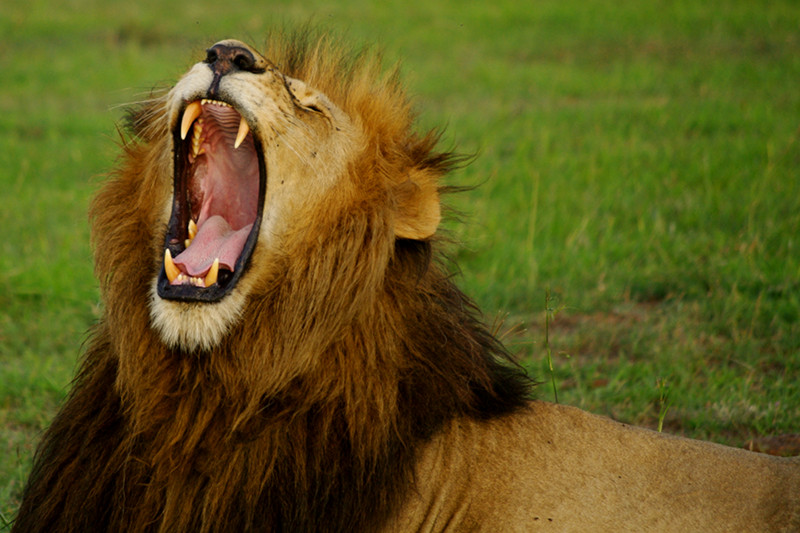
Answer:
15;33;530;532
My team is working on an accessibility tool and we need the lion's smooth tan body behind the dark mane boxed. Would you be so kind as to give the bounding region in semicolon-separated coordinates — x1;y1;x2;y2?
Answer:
391;402;800;533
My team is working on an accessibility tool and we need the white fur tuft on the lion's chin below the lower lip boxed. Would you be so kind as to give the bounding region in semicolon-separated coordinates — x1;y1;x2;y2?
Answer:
150;283;246;351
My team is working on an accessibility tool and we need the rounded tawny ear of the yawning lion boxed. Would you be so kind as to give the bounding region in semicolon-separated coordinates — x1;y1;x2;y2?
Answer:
394;170;442;240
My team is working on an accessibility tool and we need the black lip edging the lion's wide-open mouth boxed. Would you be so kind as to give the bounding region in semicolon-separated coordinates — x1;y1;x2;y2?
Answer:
156;106;267;303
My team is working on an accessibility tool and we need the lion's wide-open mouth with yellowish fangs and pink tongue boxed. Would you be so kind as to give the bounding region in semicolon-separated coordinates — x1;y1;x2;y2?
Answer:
157;99;267;302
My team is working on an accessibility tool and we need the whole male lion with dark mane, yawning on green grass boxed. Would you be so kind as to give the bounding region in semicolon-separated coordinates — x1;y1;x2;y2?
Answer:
14;31;800;532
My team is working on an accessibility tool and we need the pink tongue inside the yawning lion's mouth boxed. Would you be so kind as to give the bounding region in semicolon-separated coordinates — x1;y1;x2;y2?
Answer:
174;215;253;276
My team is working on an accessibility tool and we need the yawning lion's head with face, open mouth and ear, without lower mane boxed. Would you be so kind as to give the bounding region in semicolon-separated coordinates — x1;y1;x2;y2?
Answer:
122;40;442;350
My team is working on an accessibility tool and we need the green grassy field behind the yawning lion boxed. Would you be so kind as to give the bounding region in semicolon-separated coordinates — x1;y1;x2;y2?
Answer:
0;0;800;529
